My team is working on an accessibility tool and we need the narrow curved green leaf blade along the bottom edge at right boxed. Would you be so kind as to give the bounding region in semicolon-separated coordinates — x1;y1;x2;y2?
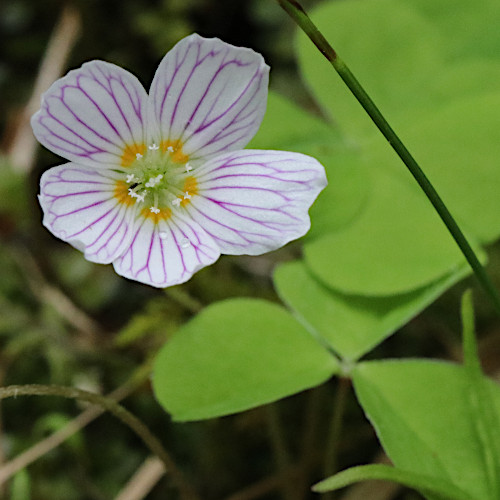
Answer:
313;465;470;500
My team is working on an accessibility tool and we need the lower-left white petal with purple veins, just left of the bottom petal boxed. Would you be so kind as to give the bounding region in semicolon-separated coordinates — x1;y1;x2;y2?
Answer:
39;163;135;264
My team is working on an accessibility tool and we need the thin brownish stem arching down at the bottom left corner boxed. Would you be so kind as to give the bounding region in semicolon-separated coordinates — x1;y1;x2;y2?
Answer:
0;384;198;500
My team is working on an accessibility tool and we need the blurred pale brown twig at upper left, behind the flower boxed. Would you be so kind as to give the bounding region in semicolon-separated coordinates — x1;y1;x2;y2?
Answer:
7;3;81;172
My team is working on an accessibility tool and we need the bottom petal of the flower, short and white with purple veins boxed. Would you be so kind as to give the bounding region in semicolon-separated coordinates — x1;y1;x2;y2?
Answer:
113;212;220;288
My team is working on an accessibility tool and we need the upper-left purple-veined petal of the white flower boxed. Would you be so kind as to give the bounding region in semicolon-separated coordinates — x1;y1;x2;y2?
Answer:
31;61;148;167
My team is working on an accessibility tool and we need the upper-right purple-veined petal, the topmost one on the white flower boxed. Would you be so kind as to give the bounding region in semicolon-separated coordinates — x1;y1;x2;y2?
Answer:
150;34;269;160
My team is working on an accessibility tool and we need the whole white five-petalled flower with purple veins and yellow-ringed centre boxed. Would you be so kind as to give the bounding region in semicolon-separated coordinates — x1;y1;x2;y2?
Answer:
31;35;326;287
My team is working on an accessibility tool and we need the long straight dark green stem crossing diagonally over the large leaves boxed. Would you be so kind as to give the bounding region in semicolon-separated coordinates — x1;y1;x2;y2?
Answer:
277;0;500;313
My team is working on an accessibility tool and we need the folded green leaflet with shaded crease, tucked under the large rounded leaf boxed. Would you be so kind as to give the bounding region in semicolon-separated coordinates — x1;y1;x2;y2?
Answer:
274;261;470;361
